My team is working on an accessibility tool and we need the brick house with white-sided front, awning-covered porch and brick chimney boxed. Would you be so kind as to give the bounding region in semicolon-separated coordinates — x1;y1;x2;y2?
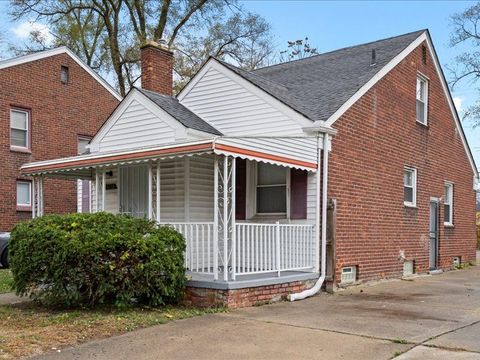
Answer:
22;30;478;307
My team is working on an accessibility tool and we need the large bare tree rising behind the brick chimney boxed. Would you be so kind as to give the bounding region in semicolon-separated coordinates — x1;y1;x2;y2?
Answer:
11;0;272;95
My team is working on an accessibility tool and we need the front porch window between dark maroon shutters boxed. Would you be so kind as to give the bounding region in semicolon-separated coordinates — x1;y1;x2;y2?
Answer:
257;163;287;214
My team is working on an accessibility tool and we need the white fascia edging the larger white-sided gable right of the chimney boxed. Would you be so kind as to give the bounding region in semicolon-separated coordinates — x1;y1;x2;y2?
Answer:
177;58;313;126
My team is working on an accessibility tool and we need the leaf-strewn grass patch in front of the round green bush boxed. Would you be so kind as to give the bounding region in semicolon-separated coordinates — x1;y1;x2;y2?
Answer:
0;302;224;359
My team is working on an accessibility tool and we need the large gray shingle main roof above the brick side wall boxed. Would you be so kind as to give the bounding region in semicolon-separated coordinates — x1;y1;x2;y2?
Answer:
222;30;426;121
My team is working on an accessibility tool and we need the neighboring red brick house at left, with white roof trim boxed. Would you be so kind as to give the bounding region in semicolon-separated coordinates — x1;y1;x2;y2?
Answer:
0;47;121;232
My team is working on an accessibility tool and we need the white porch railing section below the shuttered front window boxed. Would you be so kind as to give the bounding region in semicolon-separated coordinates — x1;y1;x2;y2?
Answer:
232;223;315;275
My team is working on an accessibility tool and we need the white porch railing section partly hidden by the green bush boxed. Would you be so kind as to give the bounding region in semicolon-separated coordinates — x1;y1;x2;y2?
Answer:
162;222;217;274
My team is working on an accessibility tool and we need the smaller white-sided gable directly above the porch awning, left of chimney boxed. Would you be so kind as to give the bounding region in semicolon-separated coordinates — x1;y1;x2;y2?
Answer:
90;90;207;152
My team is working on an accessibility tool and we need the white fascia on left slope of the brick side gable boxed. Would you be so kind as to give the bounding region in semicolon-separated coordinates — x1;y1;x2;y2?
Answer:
325;32;427;126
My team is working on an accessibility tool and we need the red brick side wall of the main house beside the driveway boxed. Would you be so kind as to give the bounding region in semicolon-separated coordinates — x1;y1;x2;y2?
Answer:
329;42;475;281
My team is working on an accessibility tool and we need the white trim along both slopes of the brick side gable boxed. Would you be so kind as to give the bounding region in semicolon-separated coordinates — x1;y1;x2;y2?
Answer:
322;30;478;178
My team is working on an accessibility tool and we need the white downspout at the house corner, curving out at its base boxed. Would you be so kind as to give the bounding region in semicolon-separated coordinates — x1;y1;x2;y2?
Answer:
288;133;329;301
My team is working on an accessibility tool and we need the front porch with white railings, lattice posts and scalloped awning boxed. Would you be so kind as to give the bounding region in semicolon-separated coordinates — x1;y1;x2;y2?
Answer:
20;136;320;290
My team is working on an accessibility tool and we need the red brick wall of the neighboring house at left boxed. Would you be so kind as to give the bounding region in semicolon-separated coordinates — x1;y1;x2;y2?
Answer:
0;54;118;231
